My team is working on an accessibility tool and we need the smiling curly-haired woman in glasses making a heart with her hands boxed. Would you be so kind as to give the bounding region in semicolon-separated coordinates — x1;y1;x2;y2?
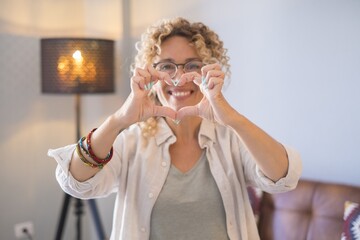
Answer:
49;18;301;240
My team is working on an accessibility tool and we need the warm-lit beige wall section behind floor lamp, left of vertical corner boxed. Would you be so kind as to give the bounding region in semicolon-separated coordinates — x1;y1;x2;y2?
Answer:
0;0;122;240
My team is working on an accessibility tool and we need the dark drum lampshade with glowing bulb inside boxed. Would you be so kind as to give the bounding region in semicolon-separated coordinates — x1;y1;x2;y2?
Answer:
41;38;114;93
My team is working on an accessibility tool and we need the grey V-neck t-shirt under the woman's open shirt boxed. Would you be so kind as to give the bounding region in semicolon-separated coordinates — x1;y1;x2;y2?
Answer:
150;153;229;240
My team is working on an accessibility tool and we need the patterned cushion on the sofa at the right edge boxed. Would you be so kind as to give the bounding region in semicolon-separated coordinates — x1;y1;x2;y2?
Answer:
341;201;360;240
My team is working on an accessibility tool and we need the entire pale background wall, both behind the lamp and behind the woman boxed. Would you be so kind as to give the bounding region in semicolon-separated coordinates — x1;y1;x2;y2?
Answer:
0;0;360;240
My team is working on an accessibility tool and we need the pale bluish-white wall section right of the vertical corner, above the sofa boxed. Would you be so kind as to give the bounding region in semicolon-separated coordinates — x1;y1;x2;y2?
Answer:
132;0;360;185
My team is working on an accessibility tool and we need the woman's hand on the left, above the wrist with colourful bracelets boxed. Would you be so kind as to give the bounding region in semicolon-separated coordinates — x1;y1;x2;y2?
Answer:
115;64;176;125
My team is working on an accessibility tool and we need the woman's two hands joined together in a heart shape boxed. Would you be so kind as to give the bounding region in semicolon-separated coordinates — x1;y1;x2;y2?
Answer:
118;64;225;128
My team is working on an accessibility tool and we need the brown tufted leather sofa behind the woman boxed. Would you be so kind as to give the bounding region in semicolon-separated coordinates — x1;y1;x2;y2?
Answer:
258;180;360;240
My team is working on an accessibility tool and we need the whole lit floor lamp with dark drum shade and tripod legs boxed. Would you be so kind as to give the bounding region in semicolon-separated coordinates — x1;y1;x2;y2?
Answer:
41;38;114;240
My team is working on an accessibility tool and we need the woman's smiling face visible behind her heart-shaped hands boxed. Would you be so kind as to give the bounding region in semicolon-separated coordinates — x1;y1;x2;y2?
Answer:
155;36;203;111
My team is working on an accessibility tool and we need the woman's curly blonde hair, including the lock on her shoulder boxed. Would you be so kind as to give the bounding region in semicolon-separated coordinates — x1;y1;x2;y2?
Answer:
131;17;231;142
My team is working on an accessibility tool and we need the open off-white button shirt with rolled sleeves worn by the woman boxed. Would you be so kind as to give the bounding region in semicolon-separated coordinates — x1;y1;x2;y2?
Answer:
48;118;302;240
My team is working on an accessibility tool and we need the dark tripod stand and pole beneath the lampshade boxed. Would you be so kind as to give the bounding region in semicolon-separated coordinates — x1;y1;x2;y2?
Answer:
55;93;106;240
